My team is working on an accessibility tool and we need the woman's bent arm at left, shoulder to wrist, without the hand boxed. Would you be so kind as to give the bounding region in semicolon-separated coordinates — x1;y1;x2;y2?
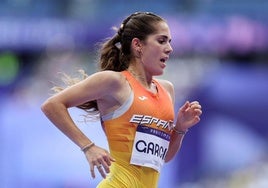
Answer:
41;73;117;148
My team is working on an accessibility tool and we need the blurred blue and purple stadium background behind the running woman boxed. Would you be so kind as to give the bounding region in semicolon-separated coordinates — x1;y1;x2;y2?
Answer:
0;0;268;188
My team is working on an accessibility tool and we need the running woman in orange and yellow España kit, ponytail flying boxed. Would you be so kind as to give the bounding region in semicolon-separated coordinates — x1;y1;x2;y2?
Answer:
41;12;202;188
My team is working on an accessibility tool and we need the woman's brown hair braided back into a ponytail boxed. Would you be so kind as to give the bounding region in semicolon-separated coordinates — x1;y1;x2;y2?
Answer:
53;12;165;113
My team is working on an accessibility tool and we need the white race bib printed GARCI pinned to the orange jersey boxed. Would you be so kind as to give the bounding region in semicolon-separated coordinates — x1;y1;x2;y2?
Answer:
130;125;170;172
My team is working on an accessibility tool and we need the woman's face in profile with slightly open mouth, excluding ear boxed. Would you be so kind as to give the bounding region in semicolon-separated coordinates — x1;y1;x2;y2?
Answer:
141;22;172;76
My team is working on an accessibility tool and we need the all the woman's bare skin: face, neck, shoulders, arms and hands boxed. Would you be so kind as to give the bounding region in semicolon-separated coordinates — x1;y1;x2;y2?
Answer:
41;12;202;181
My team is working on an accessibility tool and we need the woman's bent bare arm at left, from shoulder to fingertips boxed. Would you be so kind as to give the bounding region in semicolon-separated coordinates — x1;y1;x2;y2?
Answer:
41;71;119;177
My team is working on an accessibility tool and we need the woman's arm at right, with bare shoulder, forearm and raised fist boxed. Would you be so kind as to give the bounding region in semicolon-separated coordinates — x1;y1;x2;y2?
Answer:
159;80;202;162
